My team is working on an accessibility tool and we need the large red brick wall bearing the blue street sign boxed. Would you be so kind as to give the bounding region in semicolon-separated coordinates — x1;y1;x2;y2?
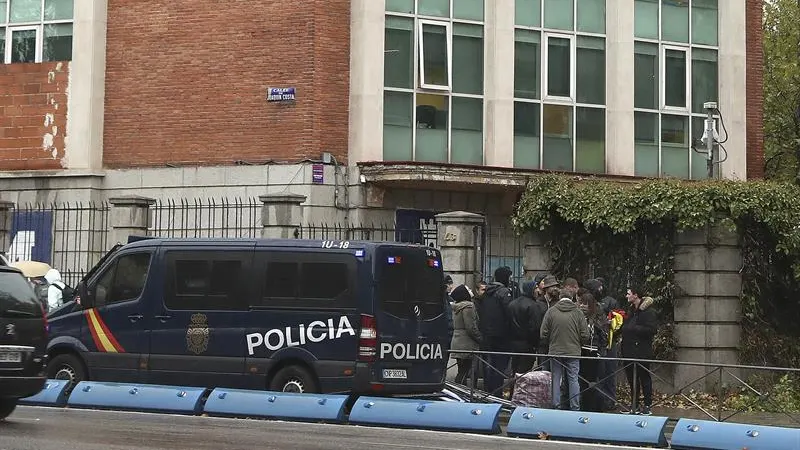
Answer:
103;0;350;168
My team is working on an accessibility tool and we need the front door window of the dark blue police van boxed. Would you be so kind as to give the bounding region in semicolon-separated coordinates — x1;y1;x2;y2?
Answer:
94;253;150;307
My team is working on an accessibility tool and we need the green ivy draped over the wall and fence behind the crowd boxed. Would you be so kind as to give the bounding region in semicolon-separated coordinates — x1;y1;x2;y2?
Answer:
512;174;800;367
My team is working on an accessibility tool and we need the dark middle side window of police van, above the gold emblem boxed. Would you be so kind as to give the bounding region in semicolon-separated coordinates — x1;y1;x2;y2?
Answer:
164;250;252;311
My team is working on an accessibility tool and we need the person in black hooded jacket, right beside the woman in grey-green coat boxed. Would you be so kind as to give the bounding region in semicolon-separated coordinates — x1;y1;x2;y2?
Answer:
478;267;512;396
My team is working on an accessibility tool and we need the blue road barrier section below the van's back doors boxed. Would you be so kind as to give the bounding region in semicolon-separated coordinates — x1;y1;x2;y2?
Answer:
349;397;500;434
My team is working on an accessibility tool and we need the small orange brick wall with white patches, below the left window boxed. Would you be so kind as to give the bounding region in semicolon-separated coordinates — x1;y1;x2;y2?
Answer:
0;63;68;170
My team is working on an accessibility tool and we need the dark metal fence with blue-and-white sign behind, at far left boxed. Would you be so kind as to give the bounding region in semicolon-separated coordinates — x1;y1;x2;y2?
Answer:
3;202;110;285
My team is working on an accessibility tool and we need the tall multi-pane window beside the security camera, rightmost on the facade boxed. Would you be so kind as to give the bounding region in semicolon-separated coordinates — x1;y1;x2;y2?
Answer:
634;0;719;179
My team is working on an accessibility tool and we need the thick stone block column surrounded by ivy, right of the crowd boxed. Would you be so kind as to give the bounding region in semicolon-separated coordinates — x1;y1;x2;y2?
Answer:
674;227;742;389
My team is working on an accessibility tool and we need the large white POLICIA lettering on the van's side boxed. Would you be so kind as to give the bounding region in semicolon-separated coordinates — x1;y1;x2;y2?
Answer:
245;316;356;356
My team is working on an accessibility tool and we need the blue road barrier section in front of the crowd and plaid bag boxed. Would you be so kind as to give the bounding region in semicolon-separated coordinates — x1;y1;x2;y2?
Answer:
507;407;668;446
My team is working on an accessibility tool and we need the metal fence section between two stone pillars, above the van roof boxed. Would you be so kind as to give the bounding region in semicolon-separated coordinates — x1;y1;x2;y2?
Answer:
148;198;263;238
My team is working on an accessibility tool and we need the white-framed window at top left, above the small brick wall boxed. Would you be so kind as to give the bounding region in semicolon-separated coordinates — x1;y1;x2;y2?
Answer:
0;0;73;64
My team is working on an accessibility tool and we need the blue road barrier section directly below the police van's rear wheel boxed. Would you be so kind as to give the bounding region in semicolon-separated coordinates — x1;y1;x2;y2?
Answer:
203;388;348;422
